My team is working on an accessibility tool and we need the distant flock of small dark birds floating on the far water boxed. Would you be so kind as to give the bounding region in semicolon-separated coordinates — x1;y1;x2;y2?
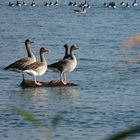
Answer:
9;0;138;13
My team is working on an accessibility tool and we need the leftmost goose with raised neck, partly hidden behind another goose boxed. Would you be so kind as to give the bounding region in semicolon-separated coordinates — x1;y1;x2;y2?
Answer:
4;39;36;81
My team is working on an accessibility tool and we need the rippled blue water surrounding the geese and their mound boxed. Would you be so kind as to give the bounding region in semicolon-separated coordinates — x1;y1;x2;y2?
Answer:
0;0;140;140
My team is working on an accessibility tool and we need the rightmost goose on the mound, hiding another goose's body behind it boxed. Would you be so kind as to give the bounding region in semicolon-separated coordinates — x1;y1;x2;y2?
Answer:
48;45;79;85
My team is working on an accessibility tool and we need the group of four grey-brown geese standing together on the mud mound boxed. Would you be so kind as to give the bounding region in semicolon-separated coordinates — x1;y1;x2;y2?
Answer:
4;39;79;86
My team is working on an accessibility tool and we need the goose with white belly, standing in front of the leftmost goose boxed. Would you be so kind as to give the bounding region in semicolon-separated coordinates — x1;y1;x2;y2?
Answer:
23;48;48;86
